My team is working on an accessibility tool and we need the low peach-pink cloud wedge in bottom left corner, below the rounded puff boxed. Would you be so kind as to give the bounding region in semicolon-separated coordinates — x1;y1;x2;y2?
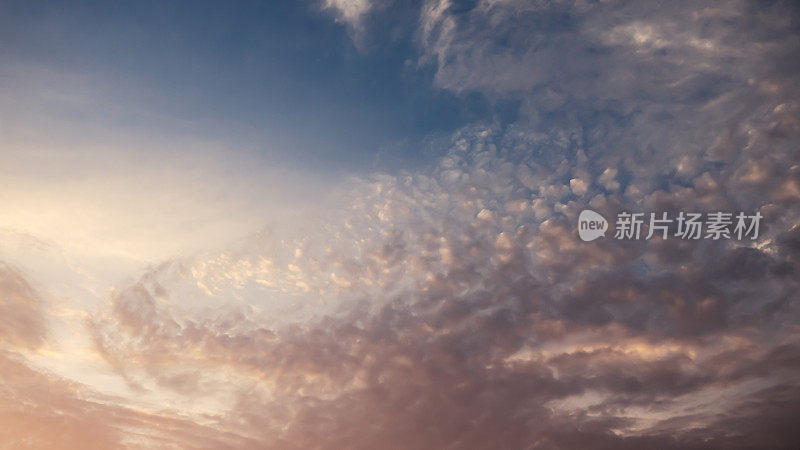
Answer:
0;353;262;449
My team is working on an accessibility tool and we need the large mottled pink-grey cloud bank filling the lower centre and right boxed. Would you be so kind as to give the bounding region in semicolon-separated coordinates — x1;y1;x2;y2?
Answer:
83;115;800;448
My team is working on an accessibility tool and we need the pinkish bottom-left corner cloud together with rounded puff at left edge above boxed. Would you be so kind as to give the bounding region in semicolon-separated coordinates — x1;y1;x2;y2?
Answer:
0;263;252;449
